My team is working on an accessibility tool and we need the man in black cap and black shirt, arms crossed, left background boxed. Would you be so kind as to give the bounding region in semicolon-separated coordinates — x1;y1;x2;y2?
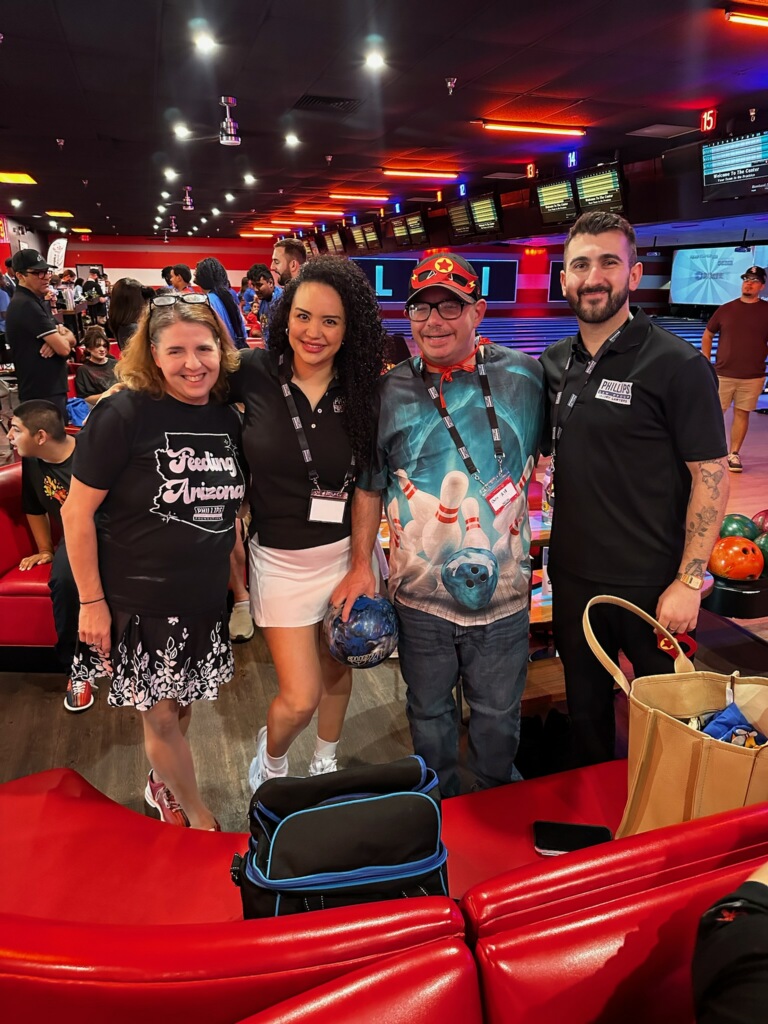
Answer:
5;249;76;416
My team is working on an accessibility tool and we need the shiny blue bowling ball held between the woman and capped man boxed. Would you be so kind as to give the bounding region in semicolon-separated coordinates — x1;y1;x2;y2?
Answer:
323;596;397;669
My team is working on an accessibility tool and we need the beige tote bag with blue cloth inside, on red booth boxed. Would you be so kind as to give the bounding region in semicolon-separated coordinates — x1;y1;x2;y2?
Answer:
583;595;768;839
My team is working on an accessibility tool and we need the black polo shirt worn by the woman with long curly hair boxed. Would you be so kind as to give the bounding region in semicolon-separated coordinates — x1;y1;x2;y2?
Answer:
229;348;352;550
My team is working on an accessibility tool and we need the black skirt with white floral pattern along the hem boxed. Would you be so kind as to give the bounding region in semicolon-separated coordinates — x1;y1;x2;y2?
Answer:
72;608;234;711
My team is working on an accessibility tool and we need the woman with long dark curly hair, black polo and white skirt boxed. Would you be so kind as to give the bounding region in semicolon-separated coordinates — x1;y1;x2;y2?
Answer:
230;256;384;790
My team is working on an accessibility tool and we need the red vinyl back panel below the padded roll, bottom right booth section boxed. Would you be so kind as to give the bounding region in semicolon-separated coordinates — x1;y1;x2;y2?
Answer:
475;853;765;1024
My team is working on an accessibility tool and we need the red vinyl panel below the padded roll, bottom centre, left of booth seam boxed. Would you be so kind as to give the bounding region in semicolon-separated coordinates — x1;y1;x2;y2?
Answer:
242;939;482;1024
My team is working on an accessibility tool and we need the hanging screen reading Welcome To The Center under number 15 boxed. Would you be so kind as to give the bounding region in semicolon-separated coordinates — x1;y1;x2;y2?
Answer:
701;132;768;202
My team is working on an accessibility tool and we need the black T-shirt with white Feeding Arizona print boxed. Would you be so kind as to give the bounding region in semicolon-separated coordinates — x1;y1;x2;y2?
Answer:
73;391;246;615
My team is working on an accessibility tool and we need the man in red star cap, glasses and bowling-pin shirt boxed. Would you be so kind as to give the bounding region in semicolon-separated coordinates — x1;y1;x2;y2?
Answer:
332;253;543;797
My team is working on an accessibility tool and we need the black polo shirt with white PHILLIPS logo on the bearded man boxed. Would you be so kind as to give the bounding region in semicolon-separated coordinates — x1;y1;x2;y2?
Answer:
542;310;727;587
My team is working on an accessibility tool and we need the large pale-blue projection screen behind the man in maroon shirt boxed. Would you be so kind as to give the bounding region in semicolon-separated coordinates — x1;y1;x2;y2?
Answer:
670;246;768;306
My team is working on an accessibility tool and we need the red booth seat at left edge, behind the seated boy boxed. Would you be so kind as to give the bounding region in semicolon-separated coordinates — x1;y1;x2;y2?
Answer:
0;462;56;647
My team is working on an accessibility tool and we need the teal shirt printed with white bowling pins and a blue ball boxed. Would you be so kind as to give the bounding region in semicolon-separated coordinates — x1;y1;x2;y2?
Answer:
357;344;544;626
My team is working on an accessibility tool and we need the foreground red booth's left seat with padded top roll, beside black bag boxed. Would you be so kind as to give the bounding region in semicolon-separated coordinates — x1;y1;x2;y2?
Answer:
0;769;464;1024
